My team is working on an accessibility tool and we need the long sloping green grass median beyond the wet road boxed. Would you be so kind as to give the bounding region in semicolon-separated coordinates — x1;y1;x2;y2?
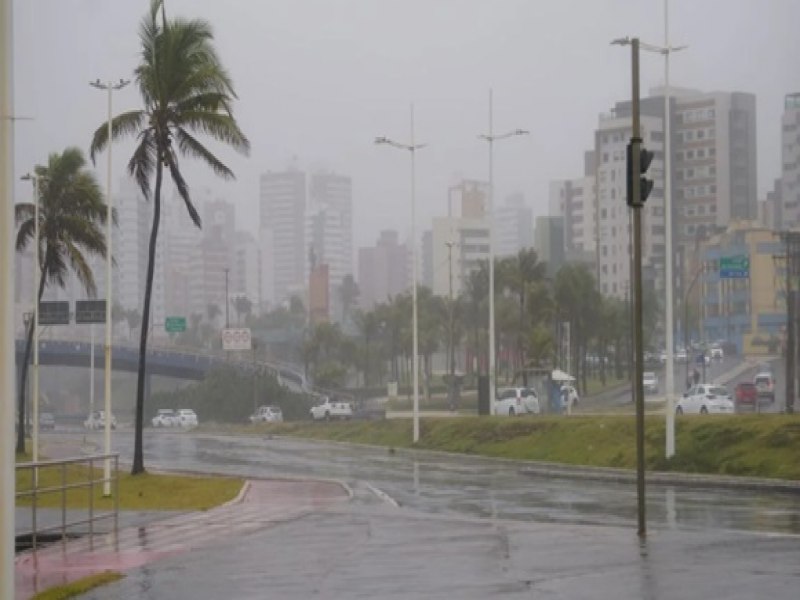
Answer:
250;415;800;480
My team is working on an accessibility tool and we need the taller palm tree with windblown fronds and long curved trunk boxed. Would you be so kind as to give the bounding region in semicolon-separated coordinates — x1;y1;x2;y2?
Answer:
91;0;250;474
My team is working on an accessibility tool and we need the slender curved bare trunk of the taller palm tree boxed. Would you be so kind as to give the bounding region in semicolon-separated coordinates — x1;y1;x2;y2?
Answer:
132;161;164;475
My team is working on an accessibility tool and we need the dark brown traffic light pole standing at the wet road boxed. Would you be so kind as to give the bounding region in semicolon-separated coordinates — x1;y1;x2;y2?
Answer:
628;38;647;537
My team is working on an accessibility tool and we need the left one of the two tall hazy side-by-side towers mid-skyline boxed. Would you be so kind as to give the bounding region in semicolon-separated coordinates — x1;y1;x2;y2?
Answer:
260;169;309;305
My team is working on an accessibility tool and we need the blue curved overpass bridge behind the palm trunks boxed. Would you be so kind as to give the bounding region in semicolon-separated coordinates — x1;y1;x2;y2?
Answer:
16;339;308;392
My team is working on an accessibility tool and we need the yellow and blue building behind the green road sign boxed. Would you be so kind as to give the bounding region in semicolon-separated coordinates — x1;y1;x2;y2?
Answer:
699;221;786;354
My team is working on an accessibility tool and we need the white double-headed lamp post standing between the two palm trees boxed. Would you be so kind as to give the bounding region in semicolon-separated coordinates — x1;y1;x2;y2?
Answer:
89;79;130;496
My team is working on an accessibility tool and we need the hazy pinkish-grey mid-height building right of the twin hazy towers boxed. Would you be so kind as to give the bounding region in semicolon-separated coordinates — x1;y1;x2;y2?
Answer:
358;230;410;310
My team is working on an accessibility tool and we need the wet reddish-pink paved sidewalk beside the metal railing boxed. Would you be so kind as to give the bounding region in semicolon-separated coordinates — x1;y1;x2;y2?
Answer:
15;480;349;599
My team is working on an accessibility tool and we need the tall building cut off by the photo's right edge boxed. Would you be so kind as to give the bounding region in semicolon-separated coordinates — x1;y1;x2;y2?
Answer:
776;93;800;229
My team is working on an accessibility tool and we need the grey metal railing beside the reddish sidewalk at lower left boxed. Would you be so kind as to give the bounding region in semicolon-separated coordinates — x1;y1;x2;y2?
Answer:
16;454;119;552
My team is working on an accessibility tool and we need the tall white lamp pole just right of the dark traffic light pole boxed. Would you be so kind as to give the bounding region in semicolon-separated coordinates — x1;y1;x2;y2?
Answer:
664;0;676;458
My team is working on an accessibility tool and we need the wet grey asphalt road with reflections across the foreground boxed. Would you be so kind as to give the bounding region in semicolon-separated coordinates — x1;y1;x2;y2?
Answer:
59;432;800;600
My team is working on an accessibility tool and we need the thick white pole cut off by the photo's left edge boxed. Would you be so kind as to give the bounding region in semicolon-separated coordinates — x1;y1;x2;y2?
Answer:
0;0;17;598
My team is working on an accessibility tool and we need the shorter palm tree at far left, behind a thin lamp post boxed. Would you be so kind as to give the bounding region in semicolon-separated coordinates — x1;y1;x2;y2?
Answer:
15;148;106;453
